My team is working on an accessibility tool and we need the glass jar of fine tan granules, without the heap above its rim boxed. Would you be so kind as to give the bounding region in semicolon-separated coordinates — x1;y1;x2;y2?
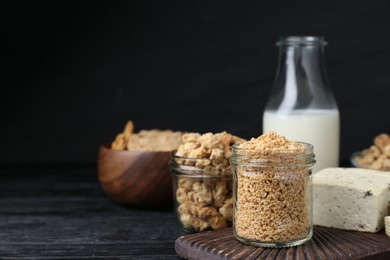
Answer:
231;143;315;247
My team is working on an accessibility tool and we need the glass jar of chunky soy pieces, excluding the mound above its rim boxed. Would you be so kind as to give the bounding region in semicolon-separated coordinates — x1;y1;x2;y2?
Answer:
170;153;233;234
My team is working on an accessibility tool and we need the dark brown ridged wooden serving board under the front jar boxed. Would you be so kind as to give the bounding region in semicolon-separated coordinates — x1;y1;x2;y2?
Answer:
175;227;390;259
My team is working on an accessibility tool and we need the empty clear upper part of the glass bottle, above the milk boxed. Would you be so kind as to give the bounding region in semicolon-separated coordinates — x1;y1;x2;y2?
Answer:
267;37;336;111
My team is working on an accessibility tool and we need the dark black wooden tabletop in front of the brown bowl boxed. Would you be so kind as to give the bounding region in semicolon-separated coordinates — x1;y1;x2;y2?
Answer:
0;166;180;259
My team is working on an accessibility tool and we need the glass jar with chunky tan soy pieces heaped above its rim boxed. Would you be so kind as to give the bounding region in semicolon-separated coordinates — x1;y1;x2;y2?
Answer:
170;132;245;233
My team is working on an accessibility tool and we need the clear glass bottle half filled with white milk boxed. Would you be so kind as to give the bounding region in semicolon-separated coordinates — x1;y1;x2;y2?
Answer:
263;36;340;173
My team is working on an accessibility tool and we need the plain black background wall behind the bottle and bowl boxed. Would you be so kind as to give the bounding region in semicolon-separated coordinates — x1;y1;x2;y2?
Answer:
0;0;390;164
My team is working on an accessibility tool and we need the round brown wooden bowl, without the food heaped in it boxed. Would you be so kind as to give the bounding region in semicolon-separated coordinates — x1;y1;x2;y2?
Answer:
97;144;173;208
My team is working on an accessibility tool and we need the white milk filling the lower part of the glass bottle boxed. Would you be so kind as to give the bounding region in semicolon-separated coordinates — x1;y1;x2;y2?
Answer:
263;109;340;173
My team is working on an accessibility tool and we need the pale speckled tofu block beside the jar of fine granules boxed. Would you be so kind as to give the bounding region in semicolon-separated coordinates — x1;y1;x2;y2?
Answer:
313;168;390;233
